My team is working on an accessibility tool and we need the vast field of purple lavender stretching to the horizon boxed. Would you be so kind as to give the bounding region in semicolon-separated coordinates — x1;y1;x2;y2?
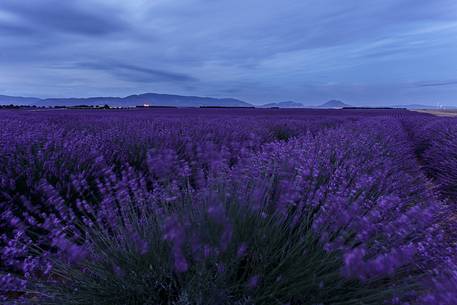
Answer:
0;109;457;305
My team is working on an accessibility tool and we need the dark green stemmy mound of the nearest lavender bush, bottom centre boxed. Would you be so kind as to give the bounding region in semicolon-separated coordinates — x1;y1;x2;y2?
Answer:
24;193;406;304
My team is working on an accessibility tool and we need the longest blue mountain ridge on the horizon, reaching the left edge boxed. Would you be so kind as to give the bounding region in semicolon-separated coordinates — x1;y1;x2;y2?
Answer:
0;93;253;107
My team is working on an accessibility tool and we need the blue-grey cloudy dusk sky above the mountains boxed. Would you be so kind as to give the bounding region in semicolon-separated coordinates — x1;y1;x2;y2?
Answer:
0;0;457;105
